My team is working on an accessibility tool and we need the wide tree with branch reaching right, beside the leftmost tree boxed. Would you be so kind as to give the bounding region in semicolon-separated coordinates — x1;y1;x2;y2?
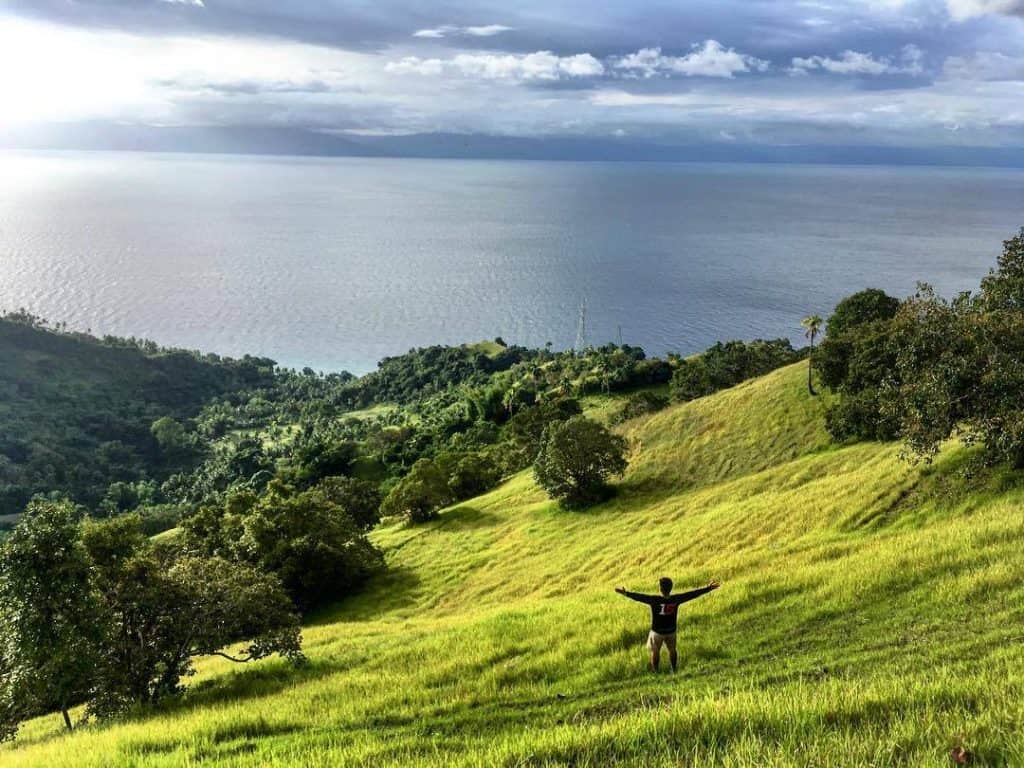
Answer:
82;515;302;717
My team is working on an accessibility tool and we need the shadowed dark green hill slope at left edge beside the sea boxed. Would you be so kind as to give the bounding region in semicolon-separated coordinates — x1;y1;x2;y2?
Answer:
0;316;272;515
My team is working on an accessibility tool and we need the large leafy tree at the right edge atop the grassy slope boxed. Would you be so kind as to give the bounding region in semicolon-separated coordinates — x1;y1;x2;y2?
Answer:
821;230;1024;468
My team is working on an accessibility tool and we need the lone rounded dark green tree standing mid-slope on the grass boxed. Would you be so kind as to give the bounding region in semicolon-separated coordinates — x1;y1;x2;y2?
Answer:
534;416;627;508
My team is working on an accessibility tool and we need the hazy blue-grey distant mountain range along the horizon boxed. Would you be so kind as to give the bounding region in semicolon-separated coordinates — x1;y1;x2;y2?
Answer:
6;123;1024;168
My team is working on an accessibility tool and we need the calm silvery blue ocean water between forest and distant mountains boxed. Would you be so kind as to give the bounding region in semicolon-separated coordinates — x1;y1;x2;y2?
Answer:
0;153;1024;372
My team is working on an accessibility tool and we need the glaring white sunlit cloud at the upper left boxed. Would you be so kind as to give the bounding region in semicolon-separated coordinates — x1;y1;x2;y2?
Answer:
0;15;383;125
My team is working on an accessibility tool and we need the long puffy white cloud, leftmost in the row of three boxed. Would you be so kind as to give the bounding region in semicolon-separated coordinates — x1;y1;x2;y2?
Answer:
385;50;604;80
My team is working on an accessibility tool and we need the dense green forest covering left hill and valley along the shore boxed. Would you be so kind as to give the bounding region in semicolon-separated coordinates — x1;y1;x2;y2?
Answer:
0;312;799;530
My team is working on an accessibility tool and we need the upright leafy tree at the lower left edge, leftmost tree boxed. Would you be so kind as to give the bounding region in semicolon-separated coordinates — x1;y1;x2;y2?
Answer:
0;502;102;735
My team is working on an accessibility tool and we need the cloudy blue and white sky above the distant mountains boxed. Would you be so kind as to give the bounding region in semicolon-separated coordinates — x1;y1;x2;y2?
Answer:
0;0;1024;147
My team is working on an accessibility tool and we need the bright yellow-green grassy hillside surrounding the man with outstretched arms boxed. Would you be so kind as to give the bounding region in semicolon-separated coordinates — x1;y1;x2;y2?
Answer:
8;365;1024;766
